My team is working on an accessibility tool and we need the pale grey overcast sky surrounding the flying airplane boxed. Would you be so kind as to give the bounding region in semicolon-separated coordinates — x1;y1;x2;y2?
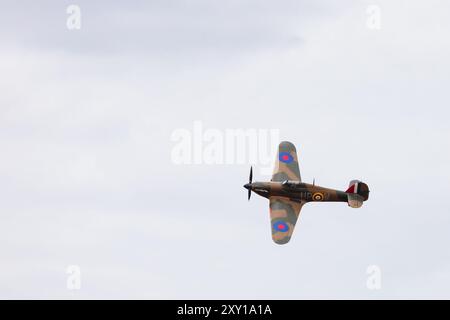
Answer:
0;0;450;299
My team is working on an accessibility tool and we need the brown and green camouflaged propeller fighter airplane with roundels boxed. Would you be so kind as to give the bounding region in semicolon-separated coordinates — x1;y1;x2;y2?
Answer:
244;141;369;244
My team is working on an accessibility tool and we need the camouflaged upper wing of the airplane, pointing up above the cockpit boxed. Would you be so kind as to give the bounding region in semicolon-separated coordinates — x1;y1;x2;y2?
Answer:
271;141;302;182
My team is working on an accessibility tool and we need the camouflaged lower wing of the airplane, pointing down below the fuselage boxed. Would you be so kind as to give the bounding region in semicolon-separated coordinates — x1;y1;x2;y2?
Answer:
269;197;304;244
